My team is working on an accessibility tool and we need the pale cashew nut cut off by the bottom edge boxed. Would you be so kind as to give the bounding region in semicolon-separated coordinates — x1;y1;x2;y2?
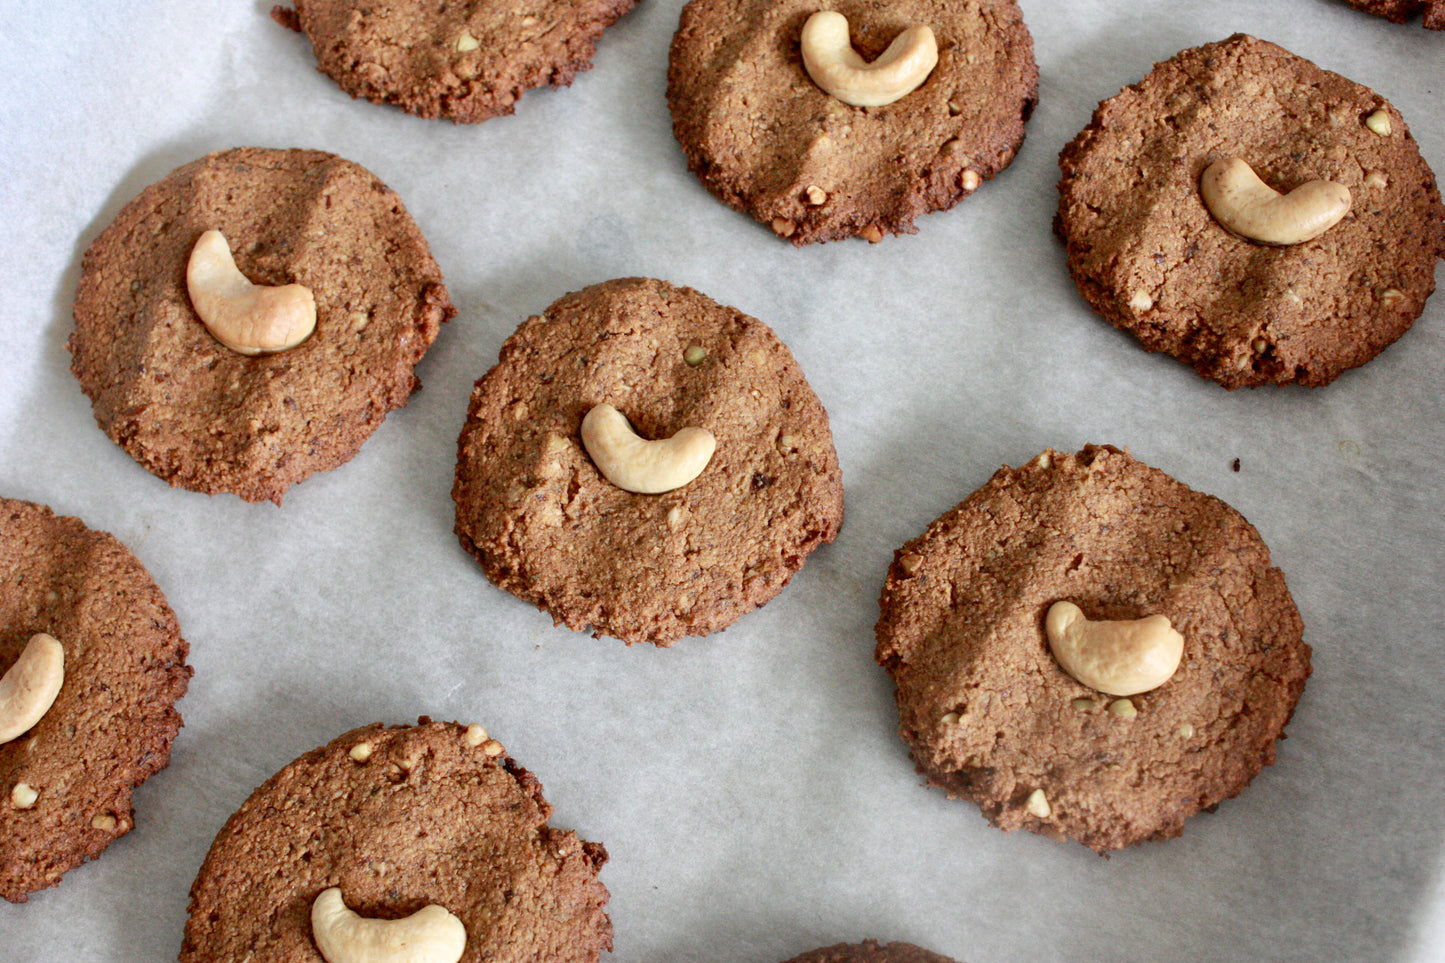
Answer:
311;886;467;963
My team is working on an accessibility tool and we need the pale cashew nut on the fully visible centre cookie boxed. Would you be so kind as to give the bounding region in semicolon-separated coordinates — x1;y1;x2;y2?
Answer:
582;403;718;495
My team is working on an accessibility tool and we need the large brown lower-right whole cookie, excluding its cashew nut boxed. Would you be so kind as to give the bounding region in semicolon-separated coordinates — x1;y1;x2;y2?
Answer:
876;445;1309;853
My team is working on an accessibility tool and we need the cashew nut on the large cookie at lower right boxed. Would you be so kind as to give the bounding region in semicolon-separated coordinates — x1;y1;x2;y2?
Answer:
1043;602;1183;696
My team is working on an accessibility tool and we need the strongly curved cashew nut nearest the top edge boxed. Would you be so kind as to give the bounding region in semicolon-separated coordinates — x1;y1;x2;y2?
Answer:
799;10;938;107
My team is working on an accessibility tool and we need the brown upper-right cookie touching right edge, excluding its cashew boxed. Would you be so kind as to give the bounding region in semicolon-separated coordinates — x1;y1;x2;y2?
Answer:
1055;35;1445;389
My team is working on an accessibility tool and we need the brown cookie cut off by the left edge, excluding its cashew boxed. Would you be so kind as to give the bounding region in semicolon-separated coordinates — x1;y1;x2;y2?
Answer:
0;499;191;902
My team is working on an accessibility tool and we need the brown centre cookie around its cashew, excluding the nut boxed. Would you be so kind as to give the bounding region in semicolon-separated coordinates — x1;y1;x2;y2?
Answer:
452;278;842;646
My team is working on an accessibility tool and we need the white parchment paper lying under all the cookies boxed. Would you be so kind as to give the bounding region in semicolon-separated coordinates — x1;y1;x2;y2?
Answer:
0;0;1445;963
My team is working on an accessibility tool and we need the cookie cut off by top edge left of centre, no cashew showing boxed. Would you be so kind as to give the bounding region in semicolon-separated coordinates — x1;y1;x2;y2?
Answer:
272;0;636;123
